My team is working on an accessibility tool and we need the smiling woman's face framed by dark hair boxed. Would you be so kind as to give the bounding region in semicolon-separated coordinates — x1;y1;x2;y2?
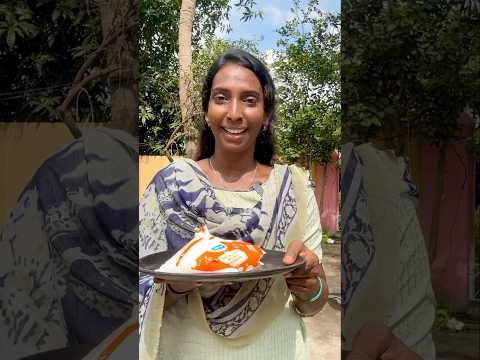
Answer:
206;64;267;152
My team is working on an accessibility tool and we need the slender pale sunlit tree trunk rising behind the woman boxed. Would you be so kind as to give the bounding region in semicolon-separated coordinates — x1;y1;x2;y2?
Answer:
178;0;197;158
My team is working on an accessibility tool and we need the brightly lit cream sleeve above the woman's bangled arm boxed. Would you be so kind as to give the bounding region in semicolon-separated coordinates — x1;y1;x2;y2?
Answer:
303;175;323;262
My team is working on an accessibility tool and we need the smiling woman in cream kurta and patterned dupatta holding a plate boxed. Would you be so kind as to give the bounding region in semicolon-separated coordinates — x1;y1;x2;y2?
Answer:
140;50;328;360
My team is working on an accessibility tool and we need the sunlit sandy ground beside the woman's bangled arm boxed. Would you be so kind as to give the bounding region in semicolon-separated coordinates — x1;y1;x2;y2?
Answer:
304;241;341;360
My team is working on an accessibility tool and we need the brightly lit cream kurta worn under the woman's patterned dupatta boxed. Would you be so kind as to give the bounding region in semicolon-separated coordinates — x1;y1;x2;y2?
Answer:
158;184;322;360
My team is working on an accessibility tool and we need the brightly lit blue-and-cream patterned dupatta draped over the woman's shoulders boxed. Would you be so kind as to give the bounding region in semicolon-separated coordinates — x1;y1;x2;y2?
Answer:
139;160;308;358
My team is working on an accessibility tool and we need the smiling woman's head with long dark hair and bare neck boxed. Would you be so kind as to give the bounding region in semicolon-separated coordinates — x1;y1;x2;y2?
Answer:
197;50;275;190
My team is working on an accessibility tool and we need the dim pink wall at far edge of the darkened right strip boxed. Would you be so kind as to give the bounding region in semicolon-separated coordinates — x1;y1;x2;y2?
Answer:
420;116;474;307
